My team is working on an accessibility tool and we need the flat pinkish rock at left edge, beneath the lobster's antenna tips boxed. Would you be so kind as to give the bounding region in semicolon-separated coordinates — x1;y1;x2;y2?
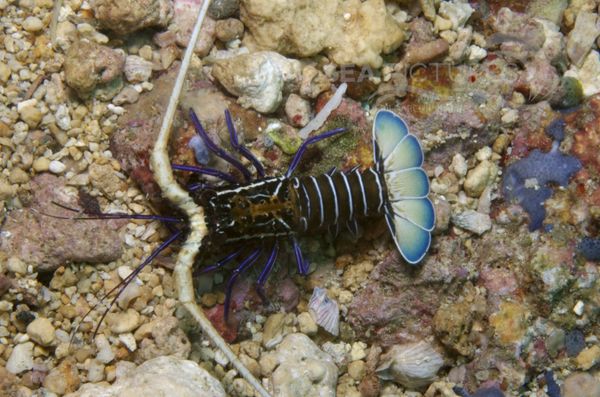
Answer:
0;174;123;271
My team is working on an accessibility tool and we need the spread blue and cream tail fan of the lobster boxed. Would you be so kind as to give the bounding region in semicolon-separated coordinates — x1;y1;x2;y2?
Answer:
373;110;435;264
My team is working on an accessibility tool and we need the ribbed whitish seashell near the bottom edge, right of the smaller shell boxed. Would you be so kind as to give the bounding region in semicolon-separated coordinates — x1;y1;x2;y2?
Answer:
375;341;444;389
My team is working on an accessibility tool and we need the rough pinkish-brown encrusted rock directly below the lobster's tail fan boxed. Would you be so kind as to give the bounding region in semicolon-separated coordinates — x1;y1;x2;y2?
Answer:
348;236;473;347
